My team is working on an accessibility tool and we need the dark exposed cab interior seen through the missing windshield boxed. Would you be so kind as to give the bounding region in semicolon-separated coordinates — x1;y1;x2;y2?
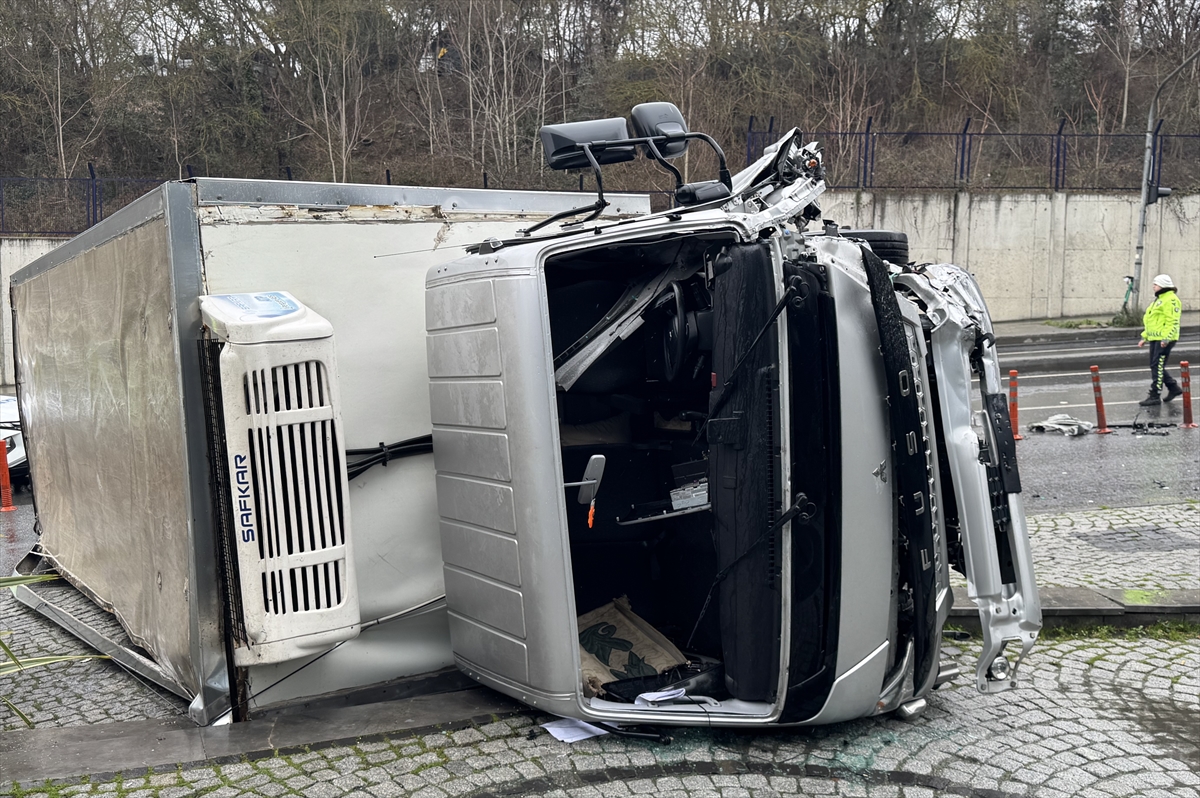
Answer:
544;232;796;715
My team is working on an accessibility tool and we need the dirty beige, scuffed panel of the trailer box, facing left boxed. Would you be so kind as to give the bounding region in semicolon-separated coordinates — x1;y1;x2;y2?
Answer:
12;215;199;692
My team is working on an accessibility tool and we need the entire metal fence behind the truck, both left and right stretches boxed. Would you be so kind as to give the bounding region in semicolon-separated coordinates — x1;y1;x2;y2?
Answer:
0;123;1200;236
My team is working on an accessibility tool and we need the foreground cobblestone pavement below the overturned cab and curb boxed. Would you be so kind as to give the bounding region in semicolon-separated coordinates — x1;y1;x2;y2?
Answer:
2;638;1200;798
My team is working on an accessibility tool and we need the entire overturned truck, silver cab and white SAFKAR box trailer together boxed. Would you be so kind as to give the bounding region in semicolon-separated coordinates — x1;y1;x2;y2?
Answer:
13;103;1040;726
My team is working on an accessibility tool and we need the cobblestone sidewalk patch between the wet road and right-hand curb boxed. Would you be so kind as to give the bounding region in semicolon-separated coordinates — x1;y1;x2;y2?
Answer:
952;502;1200;590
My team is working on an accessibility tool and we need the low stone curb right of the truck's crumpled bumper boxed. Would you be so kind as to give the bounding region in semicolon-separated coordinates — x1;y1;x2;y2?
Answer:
949;587;1200;634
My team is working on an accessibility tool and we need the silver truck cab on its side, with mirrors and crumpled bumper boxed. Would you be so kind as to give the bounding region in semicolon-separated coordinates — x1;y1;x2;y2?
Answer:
426;103;1040;726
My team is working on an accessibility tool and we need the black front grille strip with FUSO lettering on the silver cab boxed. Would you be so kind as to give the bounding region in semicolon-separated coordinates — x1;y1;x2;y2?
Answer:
862;247;940;691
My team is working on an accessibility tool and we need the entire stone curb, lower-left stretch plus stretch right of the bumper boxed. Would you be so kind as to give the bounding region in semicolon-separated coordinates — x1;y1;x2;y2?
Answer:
0;587;1200;791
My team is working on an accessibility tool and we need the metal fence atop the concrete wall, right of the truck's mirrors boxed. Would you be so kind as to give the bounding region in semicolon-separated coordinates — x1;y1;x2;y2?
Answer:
746;116;1200;191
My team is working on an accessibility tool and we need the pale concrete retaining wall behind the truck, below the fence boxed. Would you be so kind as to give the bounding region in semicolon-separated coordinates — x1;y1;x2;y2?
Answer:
0;191;1200;385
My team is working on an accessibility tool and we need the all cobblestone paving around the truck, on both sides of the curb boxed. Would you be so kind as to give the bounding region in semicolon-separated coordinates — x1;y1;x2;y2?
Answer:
0;504;1200;798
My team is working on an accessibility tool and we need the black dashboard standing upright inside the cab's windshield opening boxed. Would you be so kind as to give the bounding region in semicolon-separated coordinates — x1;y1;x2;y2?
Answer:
708;244;780;701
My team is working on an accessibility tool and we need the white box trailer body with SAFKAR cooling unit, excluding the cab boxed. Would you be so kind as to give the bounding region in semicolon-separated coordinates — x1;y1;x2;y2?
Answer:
12;179;649;724
